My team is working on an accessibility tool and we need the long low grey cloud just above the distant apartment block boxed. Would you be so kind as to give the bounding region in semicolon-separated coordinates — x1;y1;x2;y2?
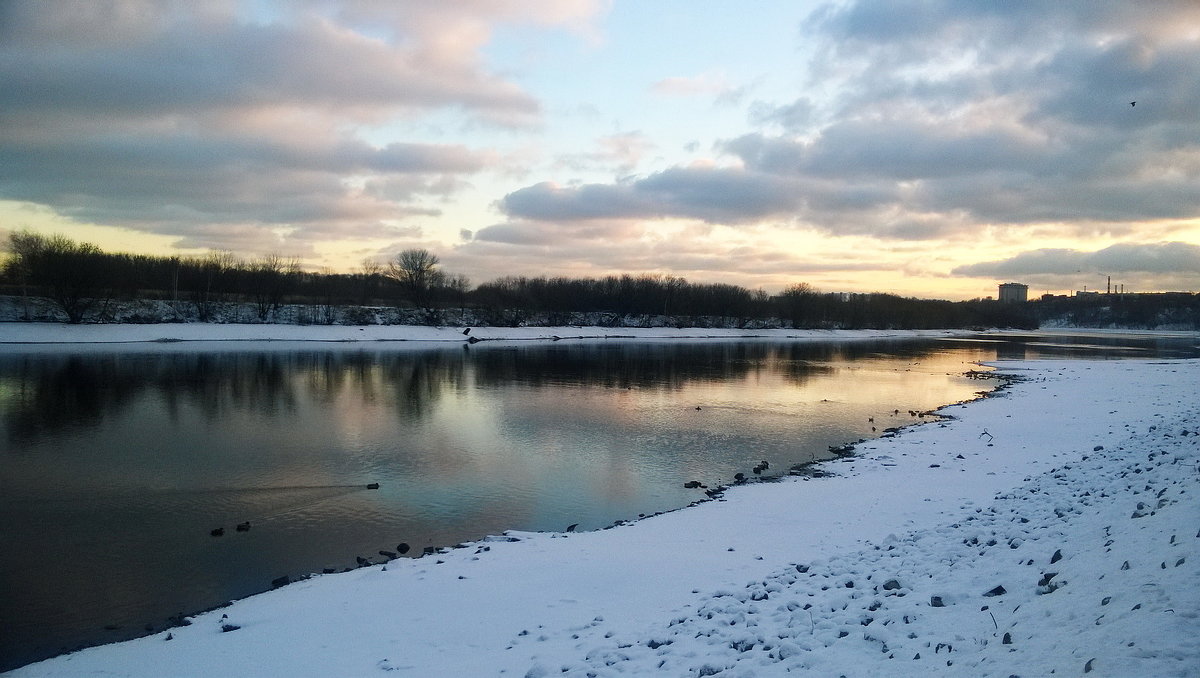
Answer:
952;242;1200;278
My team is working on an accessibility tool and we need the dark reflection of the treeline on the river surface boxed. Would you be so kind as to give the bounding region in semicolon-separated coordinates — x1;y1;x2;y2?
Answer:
0;341;964;443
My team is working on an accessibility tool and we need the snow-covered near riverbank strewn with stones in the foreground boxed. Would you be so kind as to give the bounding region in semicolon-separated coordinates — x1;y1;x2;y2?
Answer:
4;360;1200;678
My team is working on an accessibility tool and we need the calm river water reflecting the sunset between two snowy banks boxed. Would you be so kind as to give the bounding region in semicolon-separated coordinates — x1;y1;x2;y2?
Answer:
0;336;1195;670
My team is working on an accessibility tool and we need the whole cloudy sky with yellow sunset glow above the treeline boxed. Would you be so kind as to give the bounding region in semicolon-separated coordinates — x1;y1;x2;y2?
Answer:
0;0;1200;299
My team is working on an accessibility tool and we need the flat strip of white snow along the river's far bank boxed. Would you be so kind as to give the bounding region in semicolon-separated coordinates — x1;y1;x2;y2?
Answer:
0;323;967;352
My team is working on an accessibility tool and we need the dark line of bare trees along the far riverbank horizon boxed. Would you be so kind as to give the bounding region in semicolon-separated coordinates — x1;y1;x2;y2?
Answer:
0;232;1200;329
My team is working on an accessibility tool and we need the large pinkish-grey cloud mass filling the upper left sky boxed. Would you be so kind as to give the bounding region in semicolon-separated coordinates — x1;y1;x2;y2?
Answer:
0;0;598;255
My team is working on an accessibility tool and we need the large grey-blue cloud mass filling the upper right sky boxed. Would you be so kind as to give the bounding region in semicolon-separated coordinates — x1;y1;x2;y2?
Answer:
500;0;1200;240
